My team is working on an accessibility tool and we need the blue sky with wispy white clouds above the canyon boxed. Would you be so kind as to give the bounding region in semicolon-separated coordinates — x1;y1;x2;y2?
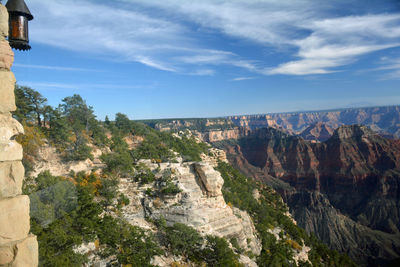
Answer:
8;0;400;119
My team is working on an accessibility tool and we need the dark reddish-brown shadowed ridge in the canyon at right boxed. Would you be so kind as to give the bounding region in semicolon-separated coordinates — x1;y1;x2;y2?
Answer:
217;125;400;264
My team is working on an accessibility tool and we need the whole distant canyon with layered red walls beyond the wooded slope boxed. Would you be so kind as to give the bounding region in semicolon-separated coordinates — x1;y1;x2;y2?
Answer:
145;106;400;266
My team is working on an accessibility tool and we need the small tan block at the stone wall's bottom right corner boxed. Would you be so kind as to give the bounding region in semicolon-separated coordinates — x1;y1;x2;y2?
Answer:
11;235;39;267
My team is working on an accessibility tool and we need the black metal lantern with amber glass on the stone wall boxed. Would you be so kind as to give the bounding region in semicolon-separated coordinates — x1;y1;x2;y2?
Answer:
6;0;33;50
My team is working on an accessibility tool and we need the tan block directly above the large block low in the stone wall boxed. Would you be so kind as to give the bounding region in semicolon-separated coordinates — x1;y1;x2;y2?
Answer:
0;161;24;199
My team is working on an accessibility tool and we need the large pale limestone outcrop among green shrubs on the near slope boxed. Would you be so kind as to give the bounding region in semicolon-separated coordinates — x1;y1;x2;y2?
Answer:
120;160;261;266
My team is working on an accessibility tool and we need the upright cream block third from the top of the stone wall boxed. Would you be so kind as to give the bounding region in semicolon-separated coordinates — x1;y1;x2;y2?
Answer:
0;71;16;113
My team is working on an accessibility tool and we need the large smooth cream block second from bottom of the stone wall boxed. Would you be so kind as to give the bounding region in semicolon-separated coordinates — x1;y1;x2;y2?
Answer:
0;196;30;246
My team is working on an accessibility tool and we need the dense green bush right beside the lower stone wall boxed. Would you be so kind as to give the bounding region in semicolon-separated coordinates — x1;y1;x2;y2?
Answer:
30;172;101;266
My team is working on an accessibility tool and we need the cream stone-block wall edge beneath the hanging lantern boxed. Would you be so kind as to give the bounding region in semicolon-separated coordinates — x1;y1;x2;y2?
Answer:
0;4;38;267
